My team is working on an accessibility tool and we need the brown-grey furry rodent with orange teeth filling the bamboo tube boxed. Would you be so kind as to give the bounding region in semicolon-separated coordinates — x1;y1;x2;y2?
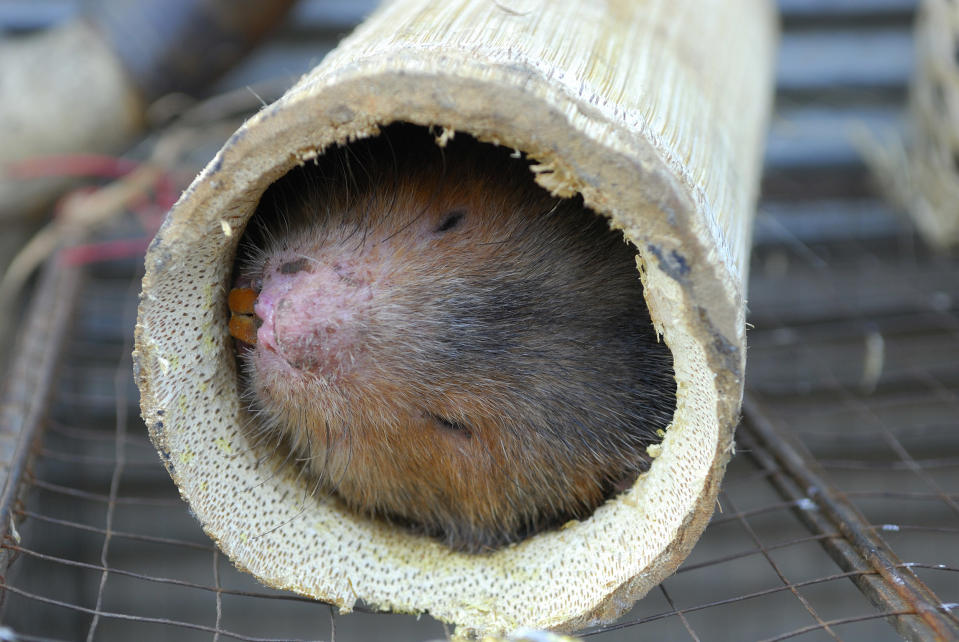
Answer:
230;125;676;552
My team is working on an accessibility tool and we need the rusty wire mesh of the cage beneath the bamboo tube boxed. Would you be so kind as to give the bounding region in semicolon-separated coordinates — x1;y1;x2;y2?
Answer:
3;169;959;640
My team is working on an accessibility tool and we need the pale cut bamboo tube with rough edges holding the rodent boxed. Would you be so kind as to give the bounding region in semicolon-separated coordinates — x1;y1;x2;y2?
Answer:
135;0;775;635
